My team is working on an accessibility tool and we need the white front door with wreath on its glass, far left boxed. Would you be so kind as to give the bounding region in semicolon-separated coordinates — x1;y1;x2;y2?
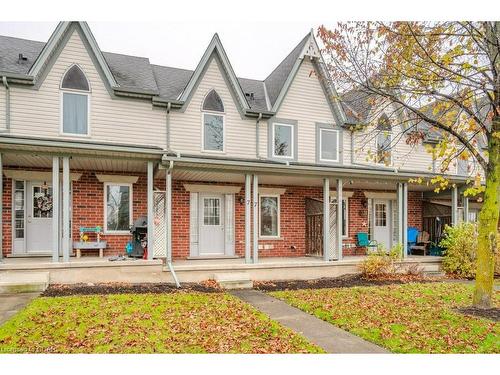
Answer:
26;181;52;254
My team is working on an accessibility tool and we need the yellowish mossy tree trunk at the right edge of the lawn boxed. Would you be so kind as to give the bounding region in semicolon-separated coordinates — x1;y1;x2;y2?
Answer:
473;117;500;308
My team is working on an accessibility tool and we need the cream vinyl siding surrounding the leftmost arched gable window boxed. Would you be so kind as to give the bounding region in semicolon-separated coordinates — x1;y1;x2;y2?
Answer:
4;31;165;147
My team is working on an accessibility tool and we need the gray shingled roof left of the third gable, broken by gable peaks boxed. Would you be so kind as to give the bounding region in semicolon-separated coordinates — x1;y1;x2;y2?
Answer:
0;34;309;111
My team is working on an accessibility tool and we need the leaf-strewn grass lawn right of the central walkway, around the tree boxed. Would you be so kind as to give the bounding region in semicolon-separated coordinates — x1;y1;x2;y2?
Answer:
271;283;500;353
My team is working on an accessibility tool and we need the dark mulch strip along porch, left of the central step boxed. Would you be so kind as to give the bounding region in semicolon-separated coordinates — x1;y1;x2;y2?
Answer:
42;281;221;297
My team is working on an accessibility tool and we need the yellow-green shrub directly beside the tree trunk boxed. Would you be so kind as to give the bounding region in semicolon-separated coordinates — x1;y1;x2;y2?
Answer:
439;223;477;278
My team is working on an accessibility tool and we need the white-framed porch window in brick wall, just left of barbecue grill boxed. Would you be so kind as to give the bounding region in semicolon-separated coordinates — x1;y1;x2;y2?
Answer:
104;182;133;234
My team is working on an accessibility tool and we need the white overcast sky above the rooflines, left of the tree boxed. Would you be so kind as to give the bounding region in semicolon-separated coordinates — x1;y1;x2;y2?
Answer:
0;20;319;79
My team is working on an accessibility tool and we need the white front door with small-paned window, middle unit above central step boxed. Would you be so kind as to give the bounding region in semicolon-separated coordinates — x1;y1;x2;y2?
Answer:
199;194;225;256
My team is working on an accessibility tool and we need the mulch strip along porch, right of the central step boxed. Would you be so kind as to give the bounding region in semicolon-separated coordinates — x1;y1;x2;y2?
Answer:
254;274;443;292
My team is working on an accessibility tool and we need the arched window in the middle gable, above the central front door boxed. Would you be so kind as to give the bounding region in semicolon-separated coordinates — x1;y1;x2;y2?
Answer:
202;90;226;152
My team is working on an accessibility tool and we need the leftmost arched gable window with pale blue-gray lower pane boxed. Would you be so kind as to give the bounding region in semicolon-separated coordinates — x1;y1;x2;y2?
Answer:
61;65;90;135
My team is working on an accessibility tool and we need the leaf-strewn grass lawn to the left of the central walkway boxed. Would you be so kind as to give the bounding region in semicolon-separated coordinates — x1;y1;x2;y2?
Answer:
0;292;321;353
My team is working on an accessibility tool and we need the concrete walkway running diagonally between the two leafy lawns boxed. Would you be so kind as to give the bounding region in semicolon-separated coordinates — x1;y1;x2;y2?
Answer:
231;289;390;353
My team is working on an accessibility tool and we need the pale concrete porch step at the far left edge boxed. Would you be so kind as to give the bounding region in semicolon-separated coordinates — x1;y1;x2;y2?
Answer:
0;271;49;294
